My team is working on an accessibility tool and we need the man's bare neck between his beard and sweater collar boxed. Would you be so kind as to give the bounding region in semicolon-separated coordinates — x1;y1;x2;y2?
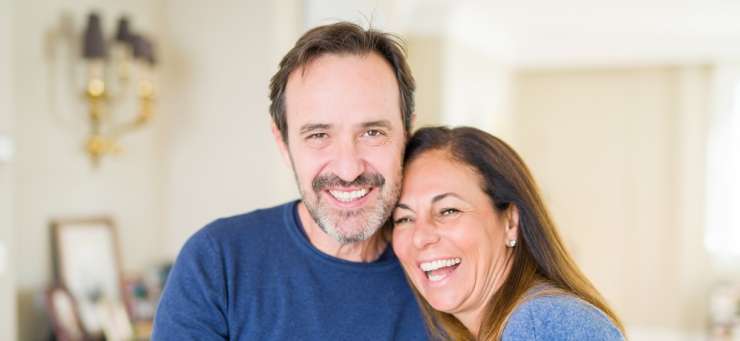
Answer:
298;202;388;263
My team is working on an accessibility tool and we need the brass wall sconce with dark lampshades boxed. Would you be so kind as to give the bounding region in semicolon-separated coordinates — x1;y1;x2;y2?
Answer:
82;13;156;165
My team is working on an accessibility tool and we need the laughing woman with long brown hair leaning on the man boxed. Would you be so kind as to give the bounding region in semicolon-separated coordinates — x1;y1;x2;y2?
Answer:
393;127;624;340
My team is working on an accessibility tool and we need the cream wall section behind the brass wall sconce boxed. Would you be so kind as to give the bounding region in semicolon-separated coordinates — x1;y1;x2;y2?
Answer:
12;0;165;340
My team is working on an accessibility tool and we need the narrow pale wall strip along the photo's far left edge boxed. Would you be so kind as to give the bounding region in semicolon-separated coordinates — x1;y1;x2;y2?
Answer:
0;0;16;340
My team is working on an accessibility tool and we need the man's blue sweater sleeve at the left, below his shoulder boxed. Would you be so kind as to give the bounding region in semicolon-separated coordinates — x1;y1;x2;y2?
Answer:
152;227;228;341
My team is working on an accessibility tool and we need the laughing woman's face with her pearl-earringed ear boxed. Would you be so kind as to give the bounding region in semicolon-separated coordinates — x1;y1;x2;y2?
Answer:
393;151;518;318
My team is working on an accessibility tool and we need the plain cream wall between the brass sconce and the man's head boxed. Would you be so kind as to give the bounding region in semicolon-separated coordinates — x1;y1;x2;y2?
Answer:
161;0;302;258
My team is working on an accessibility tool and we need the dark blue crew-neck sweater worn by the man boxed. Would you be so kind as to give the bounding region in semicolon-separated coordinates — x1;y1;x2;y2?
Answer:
152;202;427;341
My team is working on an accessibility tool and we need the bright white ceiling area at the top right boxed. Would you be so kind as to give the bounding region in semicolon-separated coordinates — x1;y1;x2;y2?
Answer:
442;0;740;65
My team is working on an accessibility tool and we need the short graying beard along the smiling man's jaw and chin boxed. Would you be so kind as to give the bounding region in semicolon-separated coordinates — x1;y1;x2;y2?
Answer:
294;173;401;245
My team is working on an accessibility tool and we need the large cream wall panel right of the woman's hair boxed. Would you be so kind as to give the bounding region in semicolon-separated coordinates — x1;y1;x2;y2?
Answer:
514;66;712;339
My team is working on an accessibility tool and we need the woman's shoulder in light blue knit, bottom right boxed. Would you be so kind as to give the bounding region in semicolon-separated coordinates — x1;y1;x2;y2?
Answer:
503;294;624;340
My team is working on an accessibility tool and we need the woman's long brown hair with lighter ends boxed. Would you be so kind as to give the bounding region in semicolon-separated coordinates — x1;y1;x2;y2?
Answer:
404;127;624;340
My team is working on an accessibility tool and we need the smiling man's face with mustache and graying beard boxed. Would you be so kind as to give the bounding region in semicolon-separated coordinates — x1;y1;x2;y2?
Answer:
281;53;406;244
